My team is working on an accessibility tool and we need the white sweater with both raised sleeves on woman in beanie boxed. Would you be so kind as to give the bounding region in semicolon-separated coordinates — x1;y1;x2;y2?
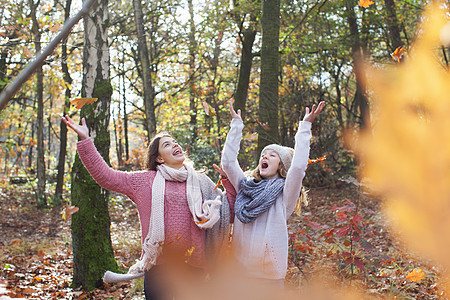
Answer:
222;119;311;279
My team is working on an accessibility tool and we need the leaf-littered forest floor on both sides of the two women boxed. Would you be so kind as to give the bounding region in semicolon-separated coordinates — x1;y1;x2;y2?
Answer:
0;185;447;300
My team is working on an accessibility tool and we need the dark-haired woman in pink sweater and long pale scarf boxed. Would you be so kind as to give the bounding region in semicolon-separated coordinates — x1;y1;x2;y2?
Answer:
62;116;236;299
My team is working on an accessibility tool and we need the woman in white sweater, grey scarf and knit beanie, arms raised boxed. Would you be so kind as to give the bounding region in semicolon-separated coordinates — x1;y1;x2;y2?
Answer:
222;100;325;286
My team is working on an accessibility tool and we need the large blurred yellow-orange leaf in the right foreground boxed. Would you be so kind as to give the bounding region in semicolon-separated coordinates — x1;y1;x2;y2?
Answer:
352;1;450;290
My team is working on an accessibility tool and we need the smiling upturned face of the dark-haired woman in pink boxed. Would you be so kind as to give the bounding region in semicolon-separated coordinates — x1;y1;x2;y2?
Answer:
156;136;186;169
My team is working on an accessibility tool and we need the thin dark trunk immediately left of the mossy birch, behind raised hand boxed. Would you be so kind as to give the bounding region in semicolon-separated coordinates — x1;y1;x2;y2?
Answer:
54;0;72;204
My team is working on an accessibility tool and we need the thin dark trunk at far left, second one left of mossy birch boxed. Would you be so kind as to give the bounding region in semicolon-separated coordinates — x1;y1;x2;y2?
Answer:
29;0;47;207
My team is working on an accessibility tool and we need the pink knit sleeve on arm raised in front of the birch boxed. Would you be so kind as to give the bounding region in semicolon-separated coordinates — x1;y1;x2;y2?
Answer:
77;138;134;199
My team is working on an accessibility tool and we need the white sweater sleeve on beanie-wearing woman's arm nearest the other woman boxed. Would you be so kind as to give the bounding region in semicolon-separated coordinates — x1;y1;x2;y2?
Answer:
222;119;245;191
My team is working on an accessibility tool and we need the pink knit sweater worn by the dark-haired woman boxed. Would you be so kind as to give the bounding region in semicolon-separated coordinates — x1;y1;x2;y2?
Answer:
77;138;236;268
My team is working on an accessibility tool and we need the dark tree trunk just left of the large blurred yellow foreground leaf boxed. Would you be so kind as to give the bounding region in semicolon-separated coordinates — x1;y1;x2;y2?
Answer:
345;0;370;129
